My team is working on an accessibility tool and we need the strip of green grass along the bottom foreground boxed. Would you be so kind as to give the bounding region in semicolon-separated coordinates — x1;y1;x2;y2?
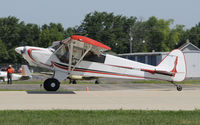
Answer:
0;110;200;125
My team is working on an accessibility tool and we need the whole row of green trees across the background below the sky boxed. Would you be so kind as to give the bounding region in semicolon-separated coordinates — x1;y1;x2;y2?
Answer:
0;11;200;63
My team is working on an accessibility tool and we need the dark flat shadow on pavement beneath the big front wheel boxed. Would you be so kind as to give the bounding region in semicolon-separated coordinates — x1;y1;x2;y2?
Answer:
26;91;76;94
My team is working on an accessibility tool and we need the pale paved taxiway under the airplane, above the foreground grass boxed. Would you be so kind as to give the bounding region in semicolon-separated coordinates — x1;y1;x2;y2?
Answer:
0;84;200;110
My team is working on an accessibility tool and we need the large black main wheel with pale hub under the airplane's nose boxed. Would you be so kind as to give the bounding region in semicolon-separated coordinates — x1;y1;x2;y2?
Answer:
44;78;60;91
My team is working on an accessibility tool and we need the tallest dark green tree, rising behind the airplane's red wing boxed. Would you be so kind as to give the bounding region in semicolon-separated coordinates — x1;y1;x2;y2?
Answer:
77;11;136;53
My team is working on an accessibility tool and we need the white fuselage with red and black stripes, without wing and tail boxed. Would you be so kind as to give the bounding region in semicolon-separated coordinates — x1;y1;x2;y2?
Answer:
16;46;174;81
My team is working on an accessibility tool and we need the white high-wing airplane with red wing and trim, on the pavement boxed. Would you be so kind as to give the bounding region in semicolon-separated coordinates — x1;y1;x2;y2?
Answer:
15;35;186;91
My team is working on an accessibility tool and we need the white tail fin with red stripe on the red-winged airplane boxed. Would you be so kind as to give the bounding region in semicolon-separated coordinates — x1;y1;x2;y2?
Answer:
156;49;187;82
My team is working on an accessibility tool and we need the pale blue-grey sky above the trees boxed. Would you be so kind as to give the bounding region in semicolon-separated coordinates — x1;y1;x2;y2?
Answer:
0;0;200;29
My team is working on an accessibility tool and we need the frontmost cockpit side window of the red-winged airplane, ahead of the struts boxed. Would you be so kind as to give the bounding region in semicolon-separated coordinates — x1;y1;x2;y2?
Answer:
56;46;69;63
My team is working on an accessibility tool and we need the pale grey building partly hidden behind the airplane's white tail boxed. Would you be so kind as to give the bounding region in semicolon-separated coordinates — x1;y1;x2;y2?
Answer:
118;42;200;79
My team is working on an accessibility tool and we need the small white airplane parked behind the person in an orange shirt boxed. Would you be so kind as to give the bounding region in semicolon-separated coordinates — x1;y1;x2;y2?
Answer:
0;65;32;82
